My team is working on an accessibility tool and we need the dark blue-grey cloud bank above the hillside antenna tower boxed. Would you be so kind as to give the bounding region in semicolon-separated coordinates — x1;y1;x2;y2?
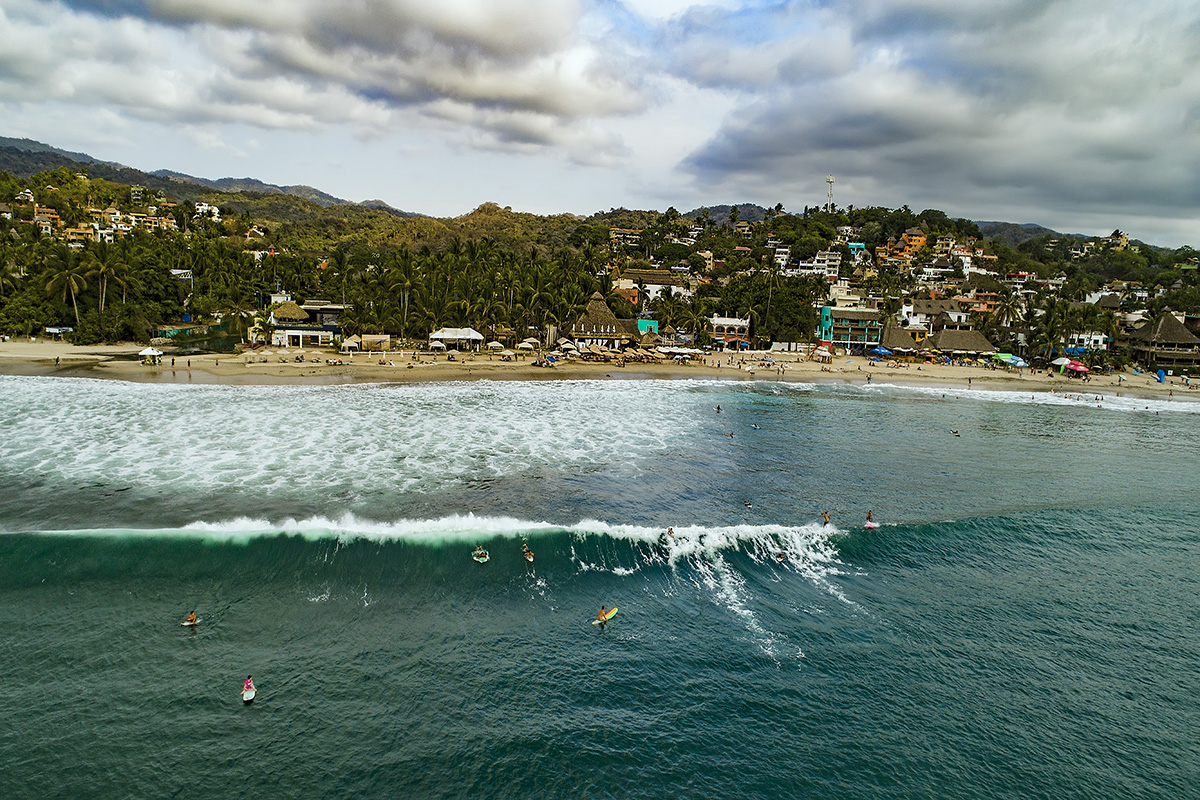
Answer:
673;0;1200;244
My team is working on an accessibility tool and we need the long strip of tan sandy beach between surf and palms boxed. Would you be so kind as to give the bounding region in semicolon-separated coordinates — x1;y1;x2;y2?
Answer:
0;338;1200;397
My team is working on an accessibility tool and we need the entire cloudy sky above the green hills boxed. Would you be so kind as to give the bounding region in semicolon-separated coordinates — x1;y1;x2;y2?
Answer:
0;0;1200;247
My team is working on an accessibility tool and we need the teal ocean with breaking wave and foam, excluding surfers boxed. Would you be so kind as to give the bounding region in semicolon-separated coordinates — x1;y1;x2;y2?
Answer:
0;377;1200;800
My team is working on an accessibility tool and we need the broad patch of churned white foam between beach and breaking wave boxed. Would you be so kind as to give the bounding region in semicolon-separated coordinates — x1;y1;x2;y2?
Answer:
0;377;701;495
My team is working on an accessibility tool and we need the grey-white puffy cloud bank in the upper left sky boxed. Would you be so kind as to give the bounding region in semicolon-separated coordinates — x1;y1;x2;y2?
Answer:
0;0;646;146
